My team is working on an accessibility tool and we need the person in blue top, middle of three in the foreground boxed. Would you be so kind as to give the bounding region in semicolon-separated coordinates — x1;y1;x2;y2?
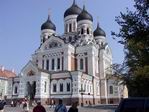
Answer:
54;99;67;112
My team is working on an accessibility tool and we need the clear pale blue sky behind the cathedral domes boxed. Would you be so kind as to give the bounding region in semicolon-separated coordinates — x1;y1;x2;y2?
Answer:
0;0;134;73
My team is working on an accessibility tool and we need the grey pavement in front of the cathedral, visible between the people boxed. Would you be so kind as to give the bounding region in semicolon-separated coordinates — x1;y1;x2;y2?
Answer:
4;105;116;112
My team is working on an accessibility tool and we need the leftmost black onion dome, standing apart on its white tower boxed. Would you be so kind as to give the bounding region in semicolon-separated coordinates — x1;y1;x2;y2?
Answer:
41;16;56;31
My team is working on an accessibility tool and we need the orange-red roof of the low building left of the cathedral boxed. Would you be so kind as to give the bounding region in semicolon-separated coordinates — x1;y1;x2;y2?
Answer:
0;69;16;78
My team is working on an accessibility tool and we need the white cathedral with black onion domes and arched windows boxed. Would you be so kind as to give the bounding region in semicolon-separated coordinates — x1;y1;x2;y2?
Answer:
7;0;121;105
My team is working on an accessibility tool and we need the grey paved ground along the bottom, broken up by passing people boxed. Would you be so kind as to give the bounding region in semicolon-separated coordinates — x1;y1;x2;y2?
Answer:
4;106;114;112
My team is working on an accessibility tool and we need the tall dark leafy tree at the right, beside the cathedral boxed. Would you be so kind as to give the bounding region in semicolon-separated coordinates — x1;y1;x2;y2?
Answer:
112;0;149;97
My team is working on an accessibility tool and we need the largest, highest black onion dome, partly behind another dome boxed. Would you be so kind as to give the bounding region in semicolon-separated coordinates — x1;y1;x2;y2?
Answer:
64;0;82;18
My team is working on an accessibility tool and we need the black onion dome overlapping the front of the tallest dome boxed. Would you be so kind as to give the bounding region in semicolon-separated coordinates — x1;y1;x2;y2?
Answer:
77;6;93;22
